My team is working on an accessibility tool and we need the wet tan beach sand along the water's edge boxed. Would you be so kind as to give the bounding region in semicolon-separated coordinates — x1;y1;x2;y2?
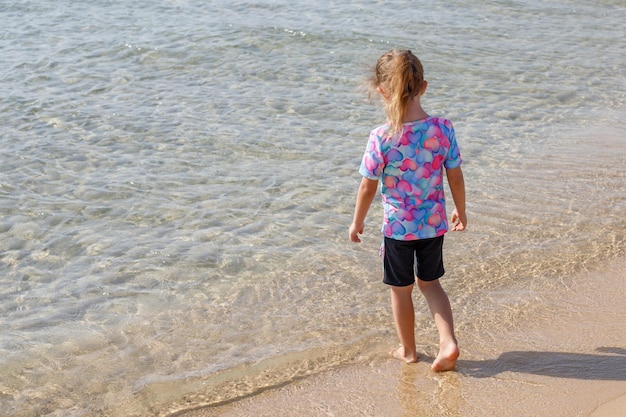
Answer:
177;260;626;417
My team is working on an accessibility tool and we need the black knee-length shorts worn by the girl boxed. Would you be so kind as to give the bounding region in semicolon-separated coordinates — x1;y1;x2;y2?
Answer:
383;236;444;287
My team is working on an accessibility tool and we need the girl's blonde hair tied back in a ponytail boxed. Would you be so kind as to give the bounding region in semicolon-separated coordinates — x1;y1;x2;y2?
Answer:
369;49;424;132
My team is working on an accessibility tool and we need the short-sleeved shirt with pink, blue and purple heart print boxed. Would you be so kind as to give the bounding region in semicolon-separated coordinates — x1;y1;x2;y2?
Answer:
359;117;462;240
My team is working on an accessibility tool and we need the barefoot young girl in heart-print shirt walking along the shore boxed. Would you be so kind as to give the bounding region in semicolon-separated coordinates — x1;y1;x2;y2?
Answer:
349;50;467;371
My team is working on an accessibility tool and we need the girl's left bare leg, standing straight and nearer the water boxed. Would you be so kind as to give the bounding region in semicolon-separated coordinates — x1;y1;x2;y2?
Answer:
390;285;417;363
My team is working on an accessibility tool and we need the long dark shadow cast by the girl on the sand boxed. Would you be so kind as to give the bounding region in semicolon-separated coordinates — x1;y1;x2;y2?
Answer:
457;347;626;381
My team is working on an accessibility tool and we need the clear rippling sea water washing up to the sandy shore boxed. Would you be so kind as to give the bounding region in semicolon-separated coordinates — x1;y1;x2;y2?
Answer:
0;0;626;416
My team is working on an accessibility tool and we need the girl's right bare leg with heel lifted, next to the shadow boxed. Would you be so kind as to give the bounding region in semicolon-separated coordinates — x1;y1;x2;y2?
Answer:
417;280;459;372
